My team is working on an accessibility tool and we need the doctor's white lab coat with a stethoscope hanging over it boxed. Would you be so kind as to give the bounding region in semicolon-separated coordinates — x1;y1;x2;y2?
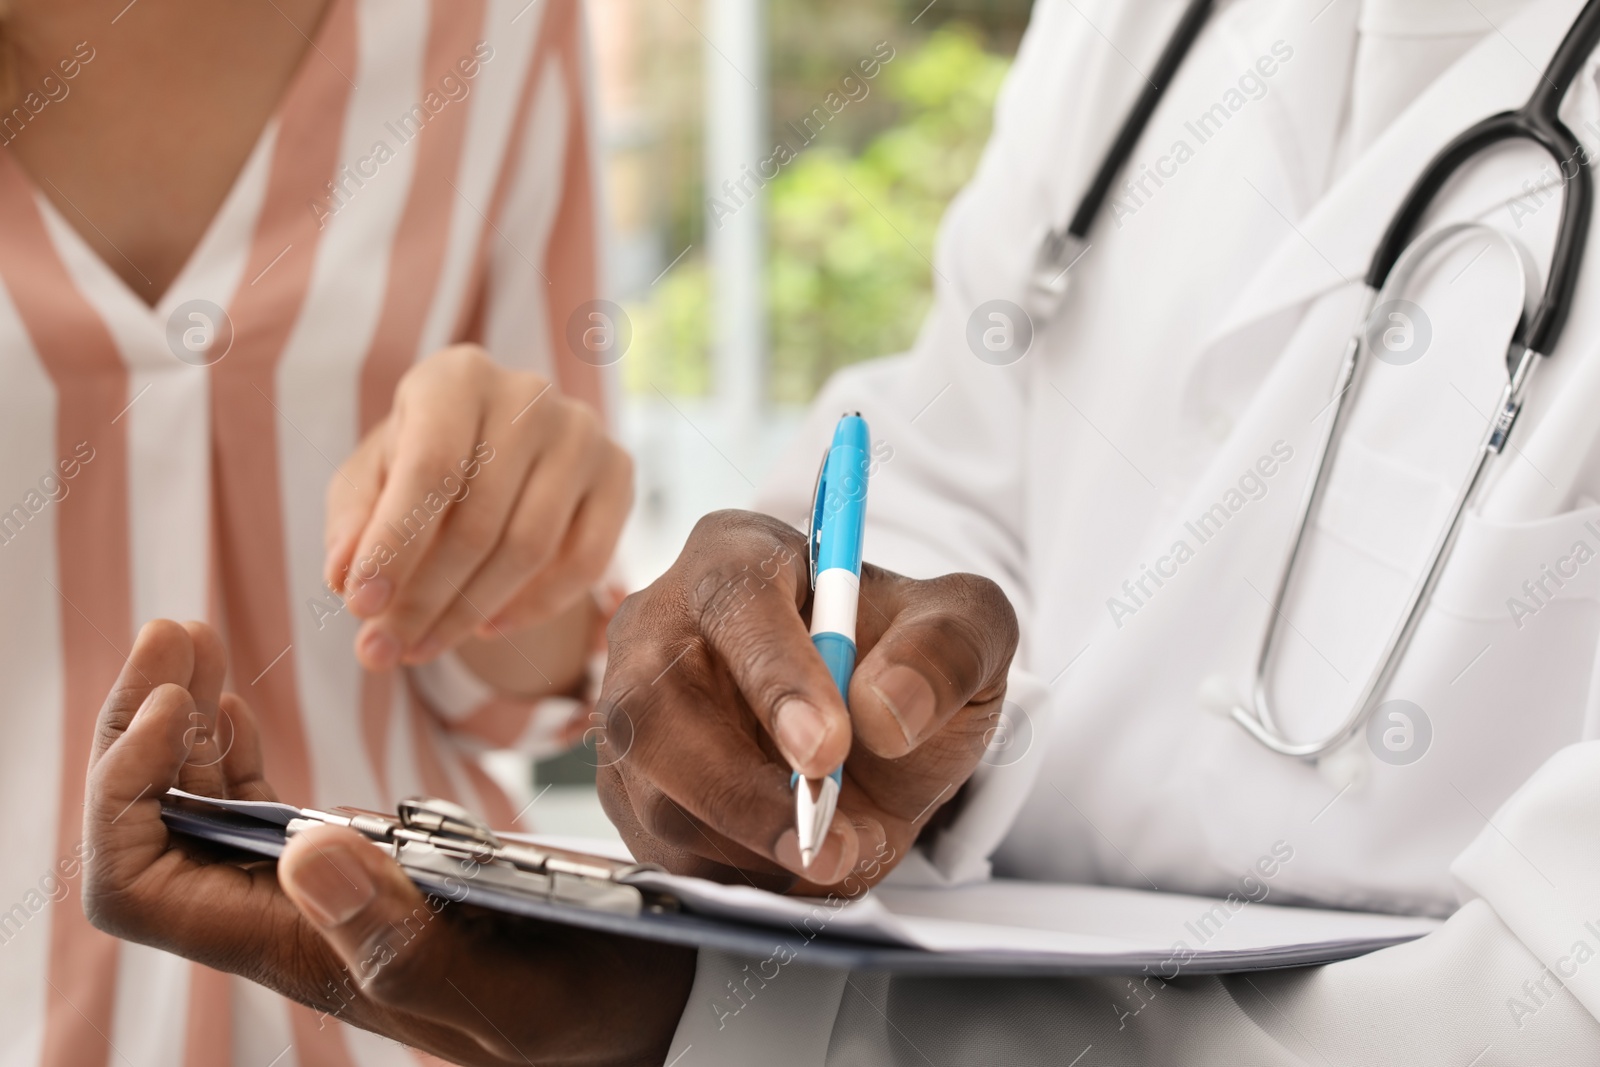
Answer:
674;0;1600;1067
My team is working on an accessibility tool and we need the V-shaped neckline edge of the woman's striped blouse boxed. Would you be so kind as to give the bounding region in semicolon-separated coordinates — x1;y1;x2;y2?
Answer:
8;0;347;323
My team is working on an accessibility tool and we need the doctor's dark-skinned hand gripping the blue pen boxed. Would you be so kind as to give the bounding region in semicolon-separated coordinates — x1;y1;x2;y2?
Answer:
592;512;1018;891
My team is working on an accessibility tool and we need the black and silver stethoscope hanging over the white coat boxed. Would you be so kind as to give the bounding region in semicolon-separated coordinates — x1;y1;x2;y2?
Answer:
1030;0;1600;760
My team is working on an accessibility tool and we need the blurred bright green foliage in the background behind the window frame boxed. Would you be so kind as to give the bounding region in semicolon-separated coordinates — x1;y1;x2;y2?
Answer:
624;21;1008;403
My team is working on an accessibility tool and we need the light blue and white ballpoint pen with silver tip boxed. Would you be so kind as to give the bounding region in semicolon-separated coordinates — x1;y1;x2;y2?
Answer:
790;413;870;867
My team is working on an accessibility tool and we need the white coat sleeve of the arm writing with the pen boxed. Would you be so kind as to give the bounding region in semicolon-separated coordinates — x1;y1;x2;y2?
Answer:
742;0;1132;881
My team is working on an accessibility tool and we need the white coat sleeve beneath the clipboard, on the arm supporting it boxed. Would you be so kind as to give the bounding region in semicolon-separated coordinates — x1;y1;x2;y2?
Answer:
669;742;1600;1067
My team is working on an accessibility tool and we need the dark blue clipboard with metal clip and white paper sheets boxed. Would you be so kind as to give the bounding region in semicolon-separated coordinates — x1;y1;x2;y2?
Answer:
162;789;1438;977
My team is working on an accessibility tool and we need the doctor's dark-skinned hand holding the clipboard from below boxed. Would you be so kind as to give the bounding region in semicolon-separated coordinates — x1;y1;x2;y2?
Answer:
80;621;694;1067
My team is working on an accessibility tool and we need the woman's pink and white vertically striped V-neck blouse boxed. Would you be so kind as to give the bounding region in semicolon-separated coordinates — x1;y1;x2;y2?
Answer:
0;0;610;1067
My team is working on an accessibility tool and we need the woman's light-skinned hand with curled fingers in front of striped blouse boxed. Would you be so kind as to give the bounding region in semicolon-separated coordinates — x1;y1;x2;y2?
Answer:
323;344;634;689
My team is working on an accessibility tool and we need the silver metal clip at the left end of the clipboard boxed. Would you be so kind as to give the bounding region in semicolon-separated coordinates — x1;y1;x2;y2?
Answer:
162;789;678;915
